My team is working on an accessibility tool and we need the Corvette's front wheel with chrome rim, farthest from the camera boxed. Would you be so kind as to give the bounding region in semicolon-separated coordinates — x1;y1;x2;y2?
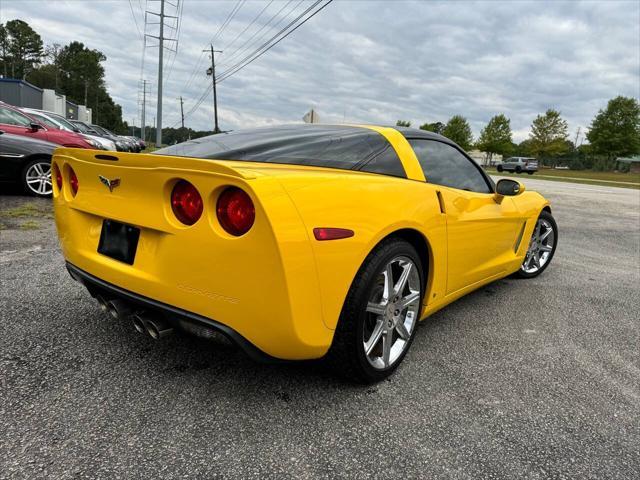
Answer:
515;210;558;278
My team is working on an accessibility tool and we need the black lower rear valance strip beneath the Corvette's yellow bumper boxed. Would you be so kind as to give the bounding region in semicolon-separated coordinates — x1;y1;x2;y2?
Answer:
66;262;283;363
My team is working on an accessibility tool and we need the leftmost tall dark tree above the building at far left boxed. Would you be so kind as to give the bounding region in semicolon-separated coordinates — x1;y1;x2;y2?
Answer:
5;19;43;79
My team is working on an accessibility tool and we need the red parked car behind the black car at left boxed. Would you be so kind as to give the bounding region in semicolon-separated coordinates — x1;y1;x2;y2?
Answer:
0;102;95;148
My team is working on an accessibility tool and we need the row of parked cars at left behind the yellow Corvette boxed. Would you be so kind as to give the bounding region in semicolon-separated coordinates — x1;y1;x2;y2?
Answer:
0;102;146;196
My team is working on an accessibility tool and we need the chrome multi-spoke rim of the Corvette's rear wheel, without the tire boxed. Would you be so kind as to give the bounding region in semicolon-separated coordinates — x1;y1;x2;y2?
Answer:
362;256;420;370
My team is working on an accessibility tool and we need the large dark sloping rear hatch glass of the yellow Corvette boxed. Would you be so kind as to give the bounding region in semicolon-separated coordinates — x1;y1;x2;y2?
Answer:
154;125;406;178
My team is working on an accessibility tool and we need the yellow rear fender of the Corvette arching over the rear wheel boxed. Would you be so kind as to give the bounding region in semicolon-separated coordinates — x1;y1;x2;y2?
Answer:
281;172;446;329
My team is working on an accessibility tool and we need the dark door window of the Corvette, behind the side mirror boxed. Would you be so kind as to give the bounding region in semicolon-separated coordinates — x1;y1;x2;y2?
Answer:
409;139;491;193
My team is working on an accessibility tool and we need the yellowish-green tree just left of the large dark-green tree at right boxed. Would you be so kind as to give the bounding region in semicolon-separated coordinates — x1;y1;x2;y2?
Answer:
529;108;571;164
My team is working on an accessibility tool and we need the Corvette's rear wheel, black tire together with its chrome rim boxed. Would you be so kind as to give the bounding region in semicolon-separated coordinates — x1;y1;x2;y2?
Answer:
327;238;424;383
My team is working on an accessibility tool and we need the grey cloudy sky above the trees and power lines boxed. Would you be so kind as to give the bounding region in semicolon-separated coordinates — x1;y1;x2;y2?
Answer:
0;0;640;141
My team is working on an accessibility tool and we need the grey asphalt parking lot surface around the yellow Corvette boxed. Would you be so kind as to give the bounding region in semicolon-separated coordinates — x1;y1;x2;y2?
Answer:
0;178;640;479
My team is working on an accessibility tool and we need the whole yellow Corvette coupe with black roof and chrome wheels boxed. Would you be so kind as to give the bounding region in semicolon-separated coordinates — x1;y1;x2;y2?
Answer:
52;125;558;382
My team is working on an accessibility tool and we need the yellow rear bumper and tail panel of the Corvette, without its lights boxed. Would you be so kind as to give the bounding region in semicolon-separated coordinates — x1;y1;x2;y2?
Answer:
53;149;333;360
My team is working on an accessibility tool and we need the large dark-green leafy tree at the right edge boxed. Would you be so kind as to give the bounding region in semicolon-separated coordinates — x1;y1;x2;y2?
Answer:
587;96;640;159
